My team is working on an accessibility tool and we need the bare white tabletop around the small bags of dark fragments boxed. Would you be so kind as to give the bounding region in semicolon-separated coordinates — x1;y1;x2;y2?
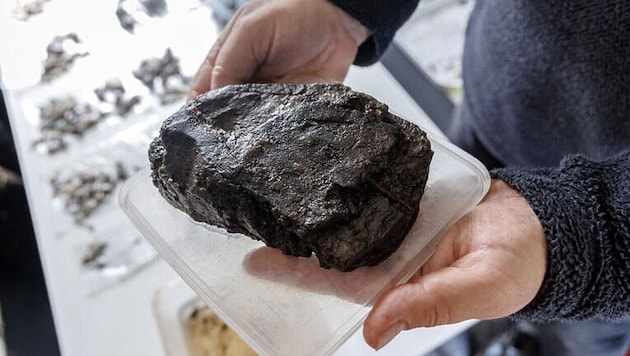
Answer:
0;0;474;356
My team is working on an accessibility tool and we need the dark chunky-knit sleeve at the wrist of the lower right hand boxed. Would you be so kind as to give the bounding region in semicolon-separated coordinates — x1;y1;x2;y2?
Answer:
492;150;630;321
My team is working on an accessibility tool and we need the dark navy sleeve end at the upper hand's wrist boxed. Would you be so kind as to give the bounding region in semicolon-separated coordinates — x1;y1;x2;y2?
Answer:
329;0;419;66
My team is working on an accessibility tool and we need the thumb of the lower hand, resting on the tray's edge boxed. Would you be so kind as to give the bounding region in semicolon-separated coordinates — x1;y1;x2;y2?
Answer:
363;266;512;350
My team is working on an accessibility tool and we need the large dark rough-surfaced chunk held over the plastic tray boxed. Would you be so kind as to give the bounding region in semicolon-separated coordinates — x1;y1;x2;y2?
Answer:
149;84;433;271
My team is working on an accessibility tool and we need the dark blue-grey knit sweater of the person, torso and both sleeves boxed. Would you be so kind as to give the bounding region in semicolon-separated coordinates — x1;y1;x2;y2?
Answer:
331;0;630;321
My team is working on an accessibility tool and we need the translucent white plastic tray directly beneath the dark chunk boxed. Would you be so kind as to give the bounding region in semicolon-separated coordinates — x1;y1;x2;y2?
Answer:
119;134;490;355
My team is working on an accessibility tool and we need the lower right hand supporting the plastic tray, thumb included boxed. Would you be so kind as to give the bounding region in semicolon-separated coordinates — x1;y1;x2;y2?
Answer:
363;180;547;349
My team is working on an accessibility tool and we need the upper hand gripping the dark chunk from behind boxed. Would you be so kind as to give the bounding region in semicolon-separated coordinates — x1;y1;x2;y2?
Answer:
188;0;370;99
